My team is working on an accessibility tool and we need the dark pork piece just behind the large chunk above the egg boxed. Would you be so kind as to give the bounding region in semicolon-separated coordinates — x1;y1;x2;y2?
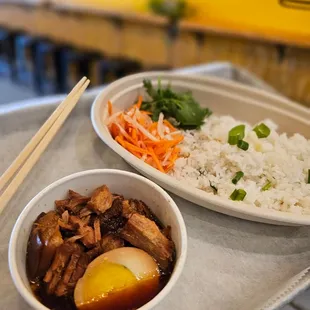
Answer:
123;199;163;228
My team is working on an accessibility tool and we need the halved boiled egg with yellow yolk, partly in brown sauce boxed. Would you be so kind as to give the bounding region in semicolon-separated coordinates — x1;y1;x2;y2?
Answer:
74;247;160;310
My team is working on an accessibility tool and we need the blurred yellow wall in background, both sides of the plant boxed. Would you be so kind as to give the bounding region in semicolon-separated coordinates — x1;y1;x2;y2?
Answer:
58;0;310;43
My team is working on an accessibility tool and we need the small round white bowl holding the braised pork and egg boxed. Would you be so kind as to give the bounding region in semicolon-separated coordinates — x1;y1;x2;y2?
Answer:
9;169;187;310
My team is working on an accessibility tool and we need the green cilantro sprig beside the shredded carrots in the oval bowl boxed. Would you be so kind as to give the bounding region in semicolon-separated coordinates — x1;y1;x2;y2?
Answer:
141;80;212;129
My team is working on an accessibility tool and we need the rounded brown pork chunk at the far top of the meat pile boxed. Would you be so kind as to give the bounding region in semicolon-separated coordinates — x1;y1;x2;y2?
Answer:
87;185;113;214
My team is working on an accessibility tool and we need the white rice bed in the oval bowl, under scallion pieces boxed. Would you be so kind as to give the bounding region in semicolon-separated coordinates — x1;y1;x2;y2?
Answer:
171;115;310;214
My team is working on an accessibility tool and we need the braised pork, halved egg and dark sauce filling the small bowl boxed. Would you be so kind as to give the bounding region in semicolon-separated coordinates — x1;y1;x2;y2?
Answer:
26;186;175;310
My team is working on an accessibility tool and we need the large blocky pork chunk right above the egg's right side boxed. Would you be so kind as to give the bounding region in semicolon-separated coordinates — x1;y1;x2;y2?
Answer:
120;213;174;271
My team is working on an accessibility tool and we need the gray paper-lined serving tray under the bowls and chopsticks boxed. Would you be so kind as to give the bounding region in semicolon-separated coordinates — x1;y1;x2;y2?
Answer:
0;63;310;310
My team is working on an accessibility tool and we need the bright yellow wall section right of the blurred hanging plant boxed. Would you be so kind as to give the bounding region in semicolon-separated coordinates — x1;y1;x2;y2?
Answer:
189;0;310;39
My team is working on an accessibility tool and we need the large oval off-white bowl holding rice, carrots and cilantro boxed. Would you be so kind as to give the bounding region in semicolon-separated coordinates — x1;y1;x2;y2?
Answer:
91;72;310;225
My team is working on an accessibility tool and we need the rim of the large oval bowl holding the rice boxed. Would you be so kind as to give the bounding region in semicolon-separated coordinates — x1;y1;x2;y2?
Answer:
91;71;310;225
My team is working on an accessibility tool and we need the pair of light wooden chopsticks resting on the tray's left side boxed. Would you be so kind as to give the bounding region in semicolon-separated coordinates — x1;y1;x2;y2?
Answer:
0;77;90;214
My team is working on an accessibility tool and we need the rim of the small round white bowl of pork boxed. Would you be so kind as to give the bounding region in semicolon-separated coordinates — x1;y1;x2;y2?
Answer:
8;169;187;310
